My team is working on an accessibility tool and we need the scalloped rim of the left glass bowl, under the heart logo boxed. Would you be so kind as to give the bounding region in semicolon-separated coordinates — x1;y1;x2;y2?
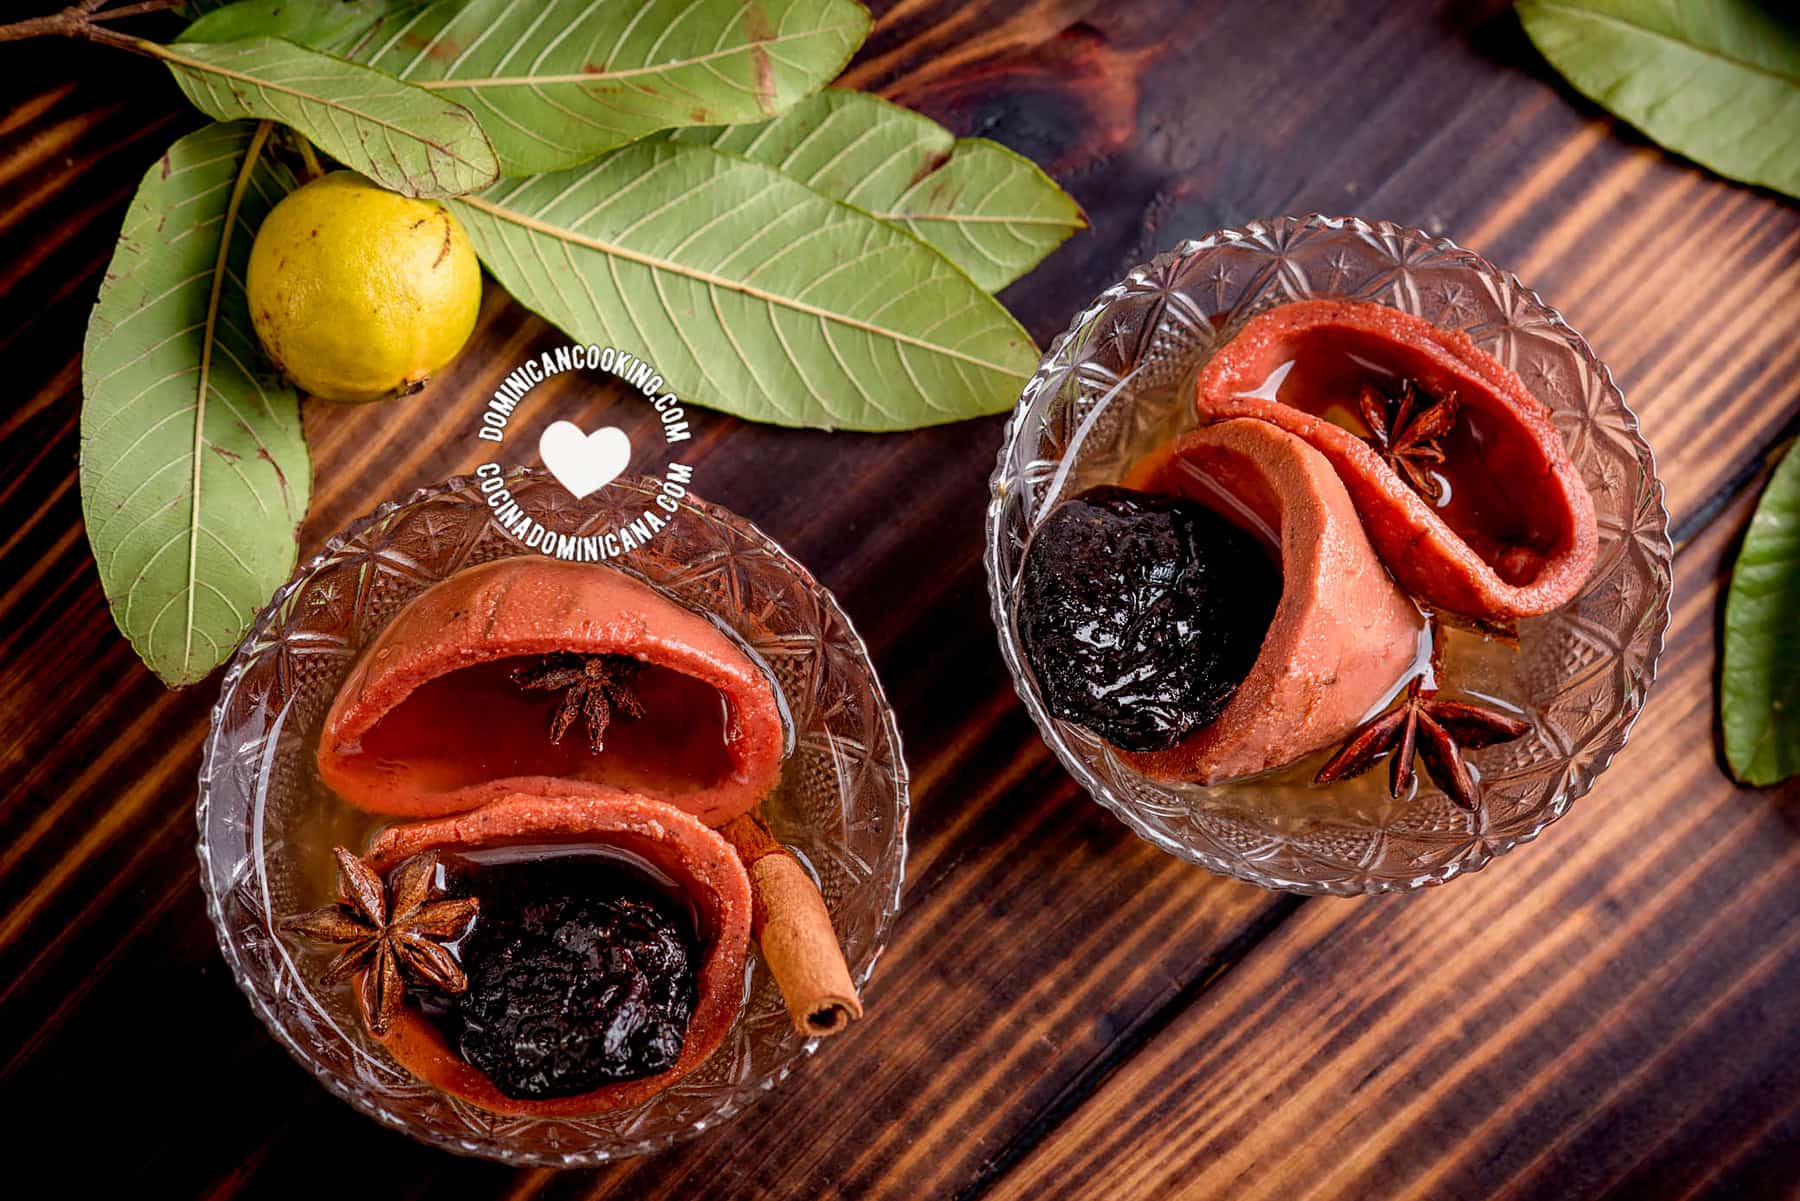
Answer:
194;468;913;1169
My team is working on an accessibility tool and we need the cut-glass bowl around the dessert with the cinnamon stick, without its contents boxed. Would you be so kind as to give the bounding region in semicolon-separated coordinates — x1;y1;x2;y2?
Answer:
198;472;907;1167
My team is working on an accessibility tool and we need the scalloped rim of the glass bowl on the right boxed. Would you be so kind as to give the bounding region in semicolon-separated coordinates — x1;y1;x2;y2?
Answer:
983;212;1674;897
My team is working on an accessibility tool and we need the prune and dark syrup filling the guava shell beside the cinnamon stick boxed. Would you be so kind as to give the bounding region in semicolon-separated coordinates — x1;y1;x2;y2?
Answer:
419;846;702;1100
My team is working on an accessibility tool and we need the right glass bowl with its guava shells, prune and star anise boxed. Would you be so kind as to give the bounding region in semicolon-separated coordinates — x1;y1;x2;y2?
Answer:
988;216;1670;893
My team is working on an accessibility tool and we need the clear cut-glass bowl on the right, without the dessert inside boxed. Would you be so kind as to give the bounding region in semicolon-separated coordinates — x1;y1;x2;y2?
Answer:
986;216;1672;895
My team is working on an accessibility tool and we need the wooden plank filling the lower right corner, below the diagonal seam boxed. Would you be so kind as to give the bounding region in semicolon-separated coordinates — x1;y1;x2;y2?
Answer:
990;489;1800;1201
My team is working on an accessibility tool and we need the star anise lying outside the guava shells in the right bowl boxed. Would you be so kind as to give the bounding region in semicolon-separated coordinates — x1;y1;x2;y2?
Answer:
1312;675;1532;810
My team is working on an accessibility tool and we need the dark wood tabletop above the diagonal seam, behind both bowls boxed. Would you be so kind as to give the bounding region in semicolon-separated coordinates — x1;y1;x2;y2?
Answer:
0;0;1800;1197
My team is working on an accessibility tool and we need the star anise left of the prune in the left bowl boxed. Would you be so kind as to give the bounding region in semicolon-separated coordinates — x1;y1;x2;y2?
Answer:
283;846;479;1037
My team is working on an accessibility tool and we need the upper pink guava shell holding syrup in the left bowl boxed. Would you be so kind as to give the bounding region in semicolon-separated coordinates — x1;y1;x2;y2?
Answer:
317;555;785;825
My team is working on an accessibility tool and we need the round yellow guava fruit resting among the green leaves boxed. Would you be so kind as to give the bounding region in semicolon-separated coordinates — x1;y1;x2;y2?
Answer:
245;171;481;403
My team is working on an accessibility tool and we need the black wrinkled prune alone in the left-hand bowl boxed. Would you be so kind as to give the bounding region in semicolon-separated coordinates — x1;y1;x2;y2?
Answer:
445;868;697;1100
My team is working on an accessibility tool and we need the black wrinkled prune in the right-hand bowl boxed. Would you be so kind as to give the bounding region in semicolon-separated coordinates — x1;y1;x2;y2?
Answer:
1019;488;1282;751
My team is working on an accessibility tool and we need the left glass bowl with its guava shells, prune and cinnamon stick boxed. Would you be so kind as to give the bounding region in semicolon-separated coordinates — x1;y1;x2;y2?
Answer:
200;472;907;1165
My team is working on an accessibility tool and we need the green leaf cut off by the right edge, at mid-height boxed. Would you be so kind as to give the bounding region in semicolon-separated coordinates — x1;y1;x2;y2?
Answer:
1719;450;1800;785
